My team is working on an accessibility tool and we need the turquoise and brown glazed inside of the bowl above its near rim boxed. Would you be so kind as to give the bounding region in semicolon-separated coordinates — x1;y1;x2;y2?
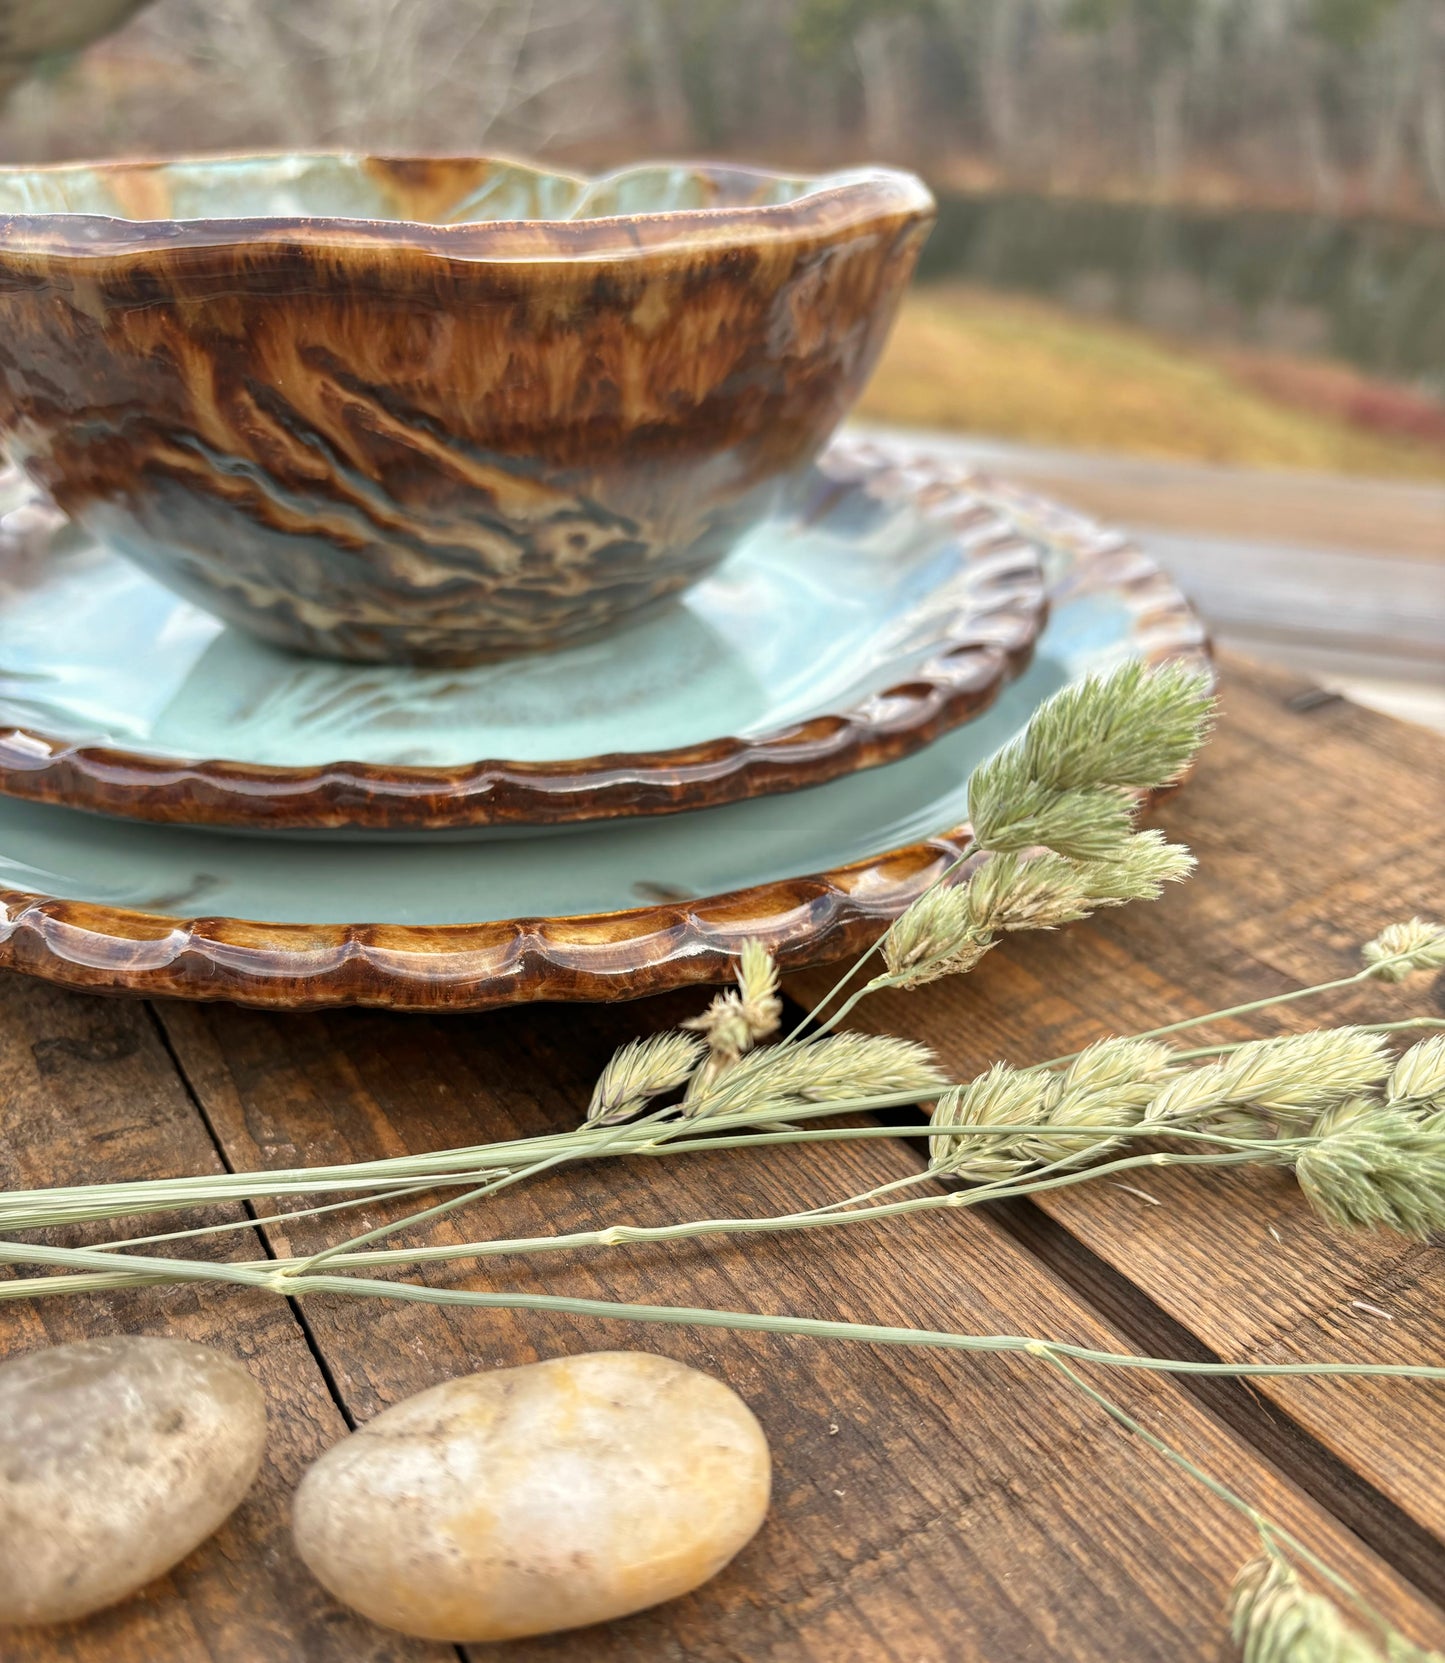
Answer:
0;155;834;225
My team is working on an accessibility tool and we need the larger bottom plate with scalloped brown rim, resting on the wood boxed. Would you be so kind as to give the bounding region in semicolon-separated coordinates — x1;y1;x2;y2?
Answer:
0;462;1207;1009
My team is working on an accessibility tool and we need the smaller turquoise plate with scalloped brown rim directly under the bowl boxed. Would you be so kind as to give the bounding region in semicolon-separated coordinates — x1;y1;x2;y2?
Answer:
0;442;1044;836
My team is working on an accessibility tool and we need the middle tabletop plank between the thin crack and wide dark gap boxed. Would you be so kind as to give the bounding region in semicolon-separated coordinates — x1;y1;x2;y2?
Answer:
163;998;1440;1663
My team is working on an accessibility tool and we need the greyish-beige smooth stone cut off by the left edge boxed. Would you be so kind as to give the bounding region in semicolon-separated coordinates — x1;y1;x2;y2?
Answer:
0;1335;266;1623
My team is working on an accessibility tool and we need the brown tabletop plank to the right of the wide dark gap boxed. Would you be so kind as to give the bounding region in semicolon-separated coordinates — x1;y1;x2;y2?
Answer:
784;664;1445;1535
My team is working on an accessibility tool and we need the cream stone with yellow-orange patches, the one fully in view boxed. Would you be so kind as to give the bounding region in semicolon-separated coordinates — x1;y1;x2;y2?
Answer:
294;1352;770;1641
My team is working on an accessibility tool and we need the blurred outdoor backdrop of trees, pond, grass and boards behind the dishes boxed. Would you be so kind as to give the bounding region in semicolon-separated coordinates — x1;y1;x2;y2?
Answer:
0;0;1445;728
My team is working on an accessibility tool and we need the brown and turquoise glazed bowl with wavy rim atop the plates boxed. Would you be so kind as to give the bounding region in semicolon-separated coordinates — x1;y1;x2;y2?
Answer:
0;155;933;664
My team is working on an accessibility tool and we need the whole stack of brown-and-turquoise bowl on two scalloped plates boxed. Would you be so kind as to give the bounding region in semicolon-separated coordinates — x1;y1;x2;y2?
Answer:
0;156;1202;1009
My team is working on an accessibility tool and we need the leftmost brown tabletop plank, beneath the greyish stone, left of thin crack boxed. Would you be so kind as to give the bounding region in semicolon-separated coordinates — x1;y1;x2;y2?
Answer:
0;976;435;1663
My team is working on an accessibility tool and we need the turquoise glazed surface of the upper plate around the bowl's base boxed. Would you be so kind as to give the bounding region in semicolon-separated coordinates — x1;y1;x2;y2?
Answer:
0;492;1019;768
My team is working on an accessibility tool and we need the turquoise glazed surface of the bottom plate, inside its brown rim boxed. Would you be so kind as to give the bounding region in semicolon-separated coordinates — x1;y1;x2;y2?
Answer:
0;590;1137;925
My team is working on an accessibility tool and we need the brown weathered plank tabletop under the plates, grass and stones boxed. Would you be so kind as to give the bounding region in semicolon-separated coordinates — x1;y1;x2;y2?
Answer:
0;662;1445;1663
